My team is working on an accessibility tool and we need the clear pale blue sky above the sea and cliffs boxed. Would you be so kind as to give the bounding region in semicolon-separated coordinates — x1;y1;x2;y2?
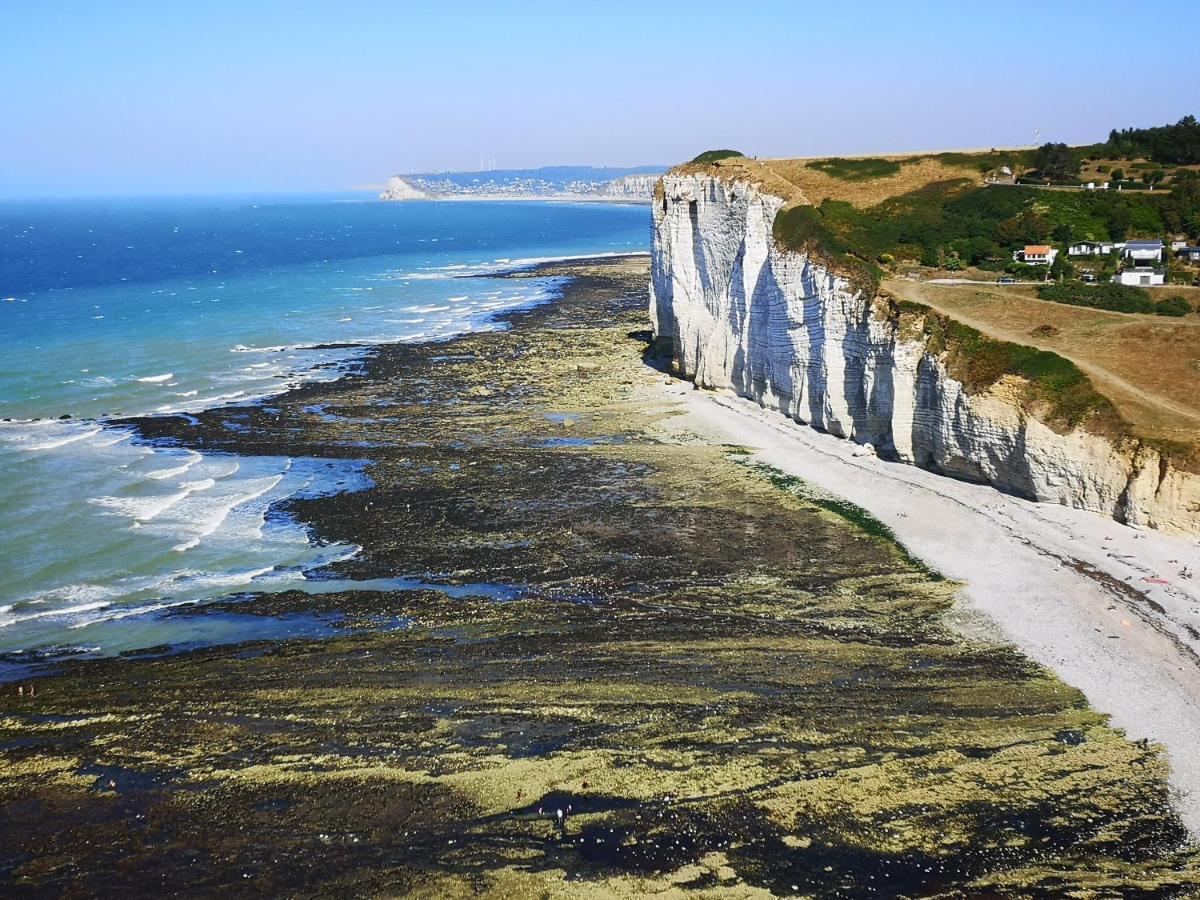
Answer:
0;0;1200;196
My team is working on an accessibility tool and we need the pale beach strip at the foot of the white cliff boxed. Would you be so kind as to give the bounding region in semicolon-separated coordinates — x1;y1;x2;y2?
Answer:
661;380;1200;834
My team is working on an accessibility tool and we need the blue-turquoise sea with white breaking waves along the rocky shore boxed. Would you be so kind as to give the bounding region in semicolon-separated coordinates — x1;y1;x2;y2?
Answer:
0;196;650;679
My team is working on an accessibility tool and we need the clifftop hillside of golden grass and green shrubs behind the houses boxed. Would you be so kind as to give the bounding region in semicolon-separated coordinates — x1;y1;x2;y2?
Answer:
676;150;1200;286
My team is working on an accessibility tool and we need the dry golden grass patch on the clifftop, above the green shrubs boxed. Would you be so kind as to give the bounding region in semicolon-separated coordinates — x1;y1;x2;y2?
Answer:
684;156;982;208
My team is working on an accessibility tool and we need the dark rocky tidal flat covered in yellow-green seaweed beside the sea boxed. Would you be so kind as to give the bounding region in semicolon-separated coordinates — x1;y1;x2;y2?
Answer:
0;258;1200;898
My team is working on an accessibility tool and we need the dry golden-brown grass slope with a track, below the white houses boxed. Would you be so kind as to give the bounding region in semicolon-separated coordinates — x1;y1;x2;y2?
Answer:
883;278;1200;444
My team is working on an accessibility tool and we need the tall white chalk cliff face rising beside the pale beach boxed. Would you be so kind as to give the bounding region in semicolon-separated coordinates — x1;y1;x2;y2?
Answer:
650;174;1200;534
